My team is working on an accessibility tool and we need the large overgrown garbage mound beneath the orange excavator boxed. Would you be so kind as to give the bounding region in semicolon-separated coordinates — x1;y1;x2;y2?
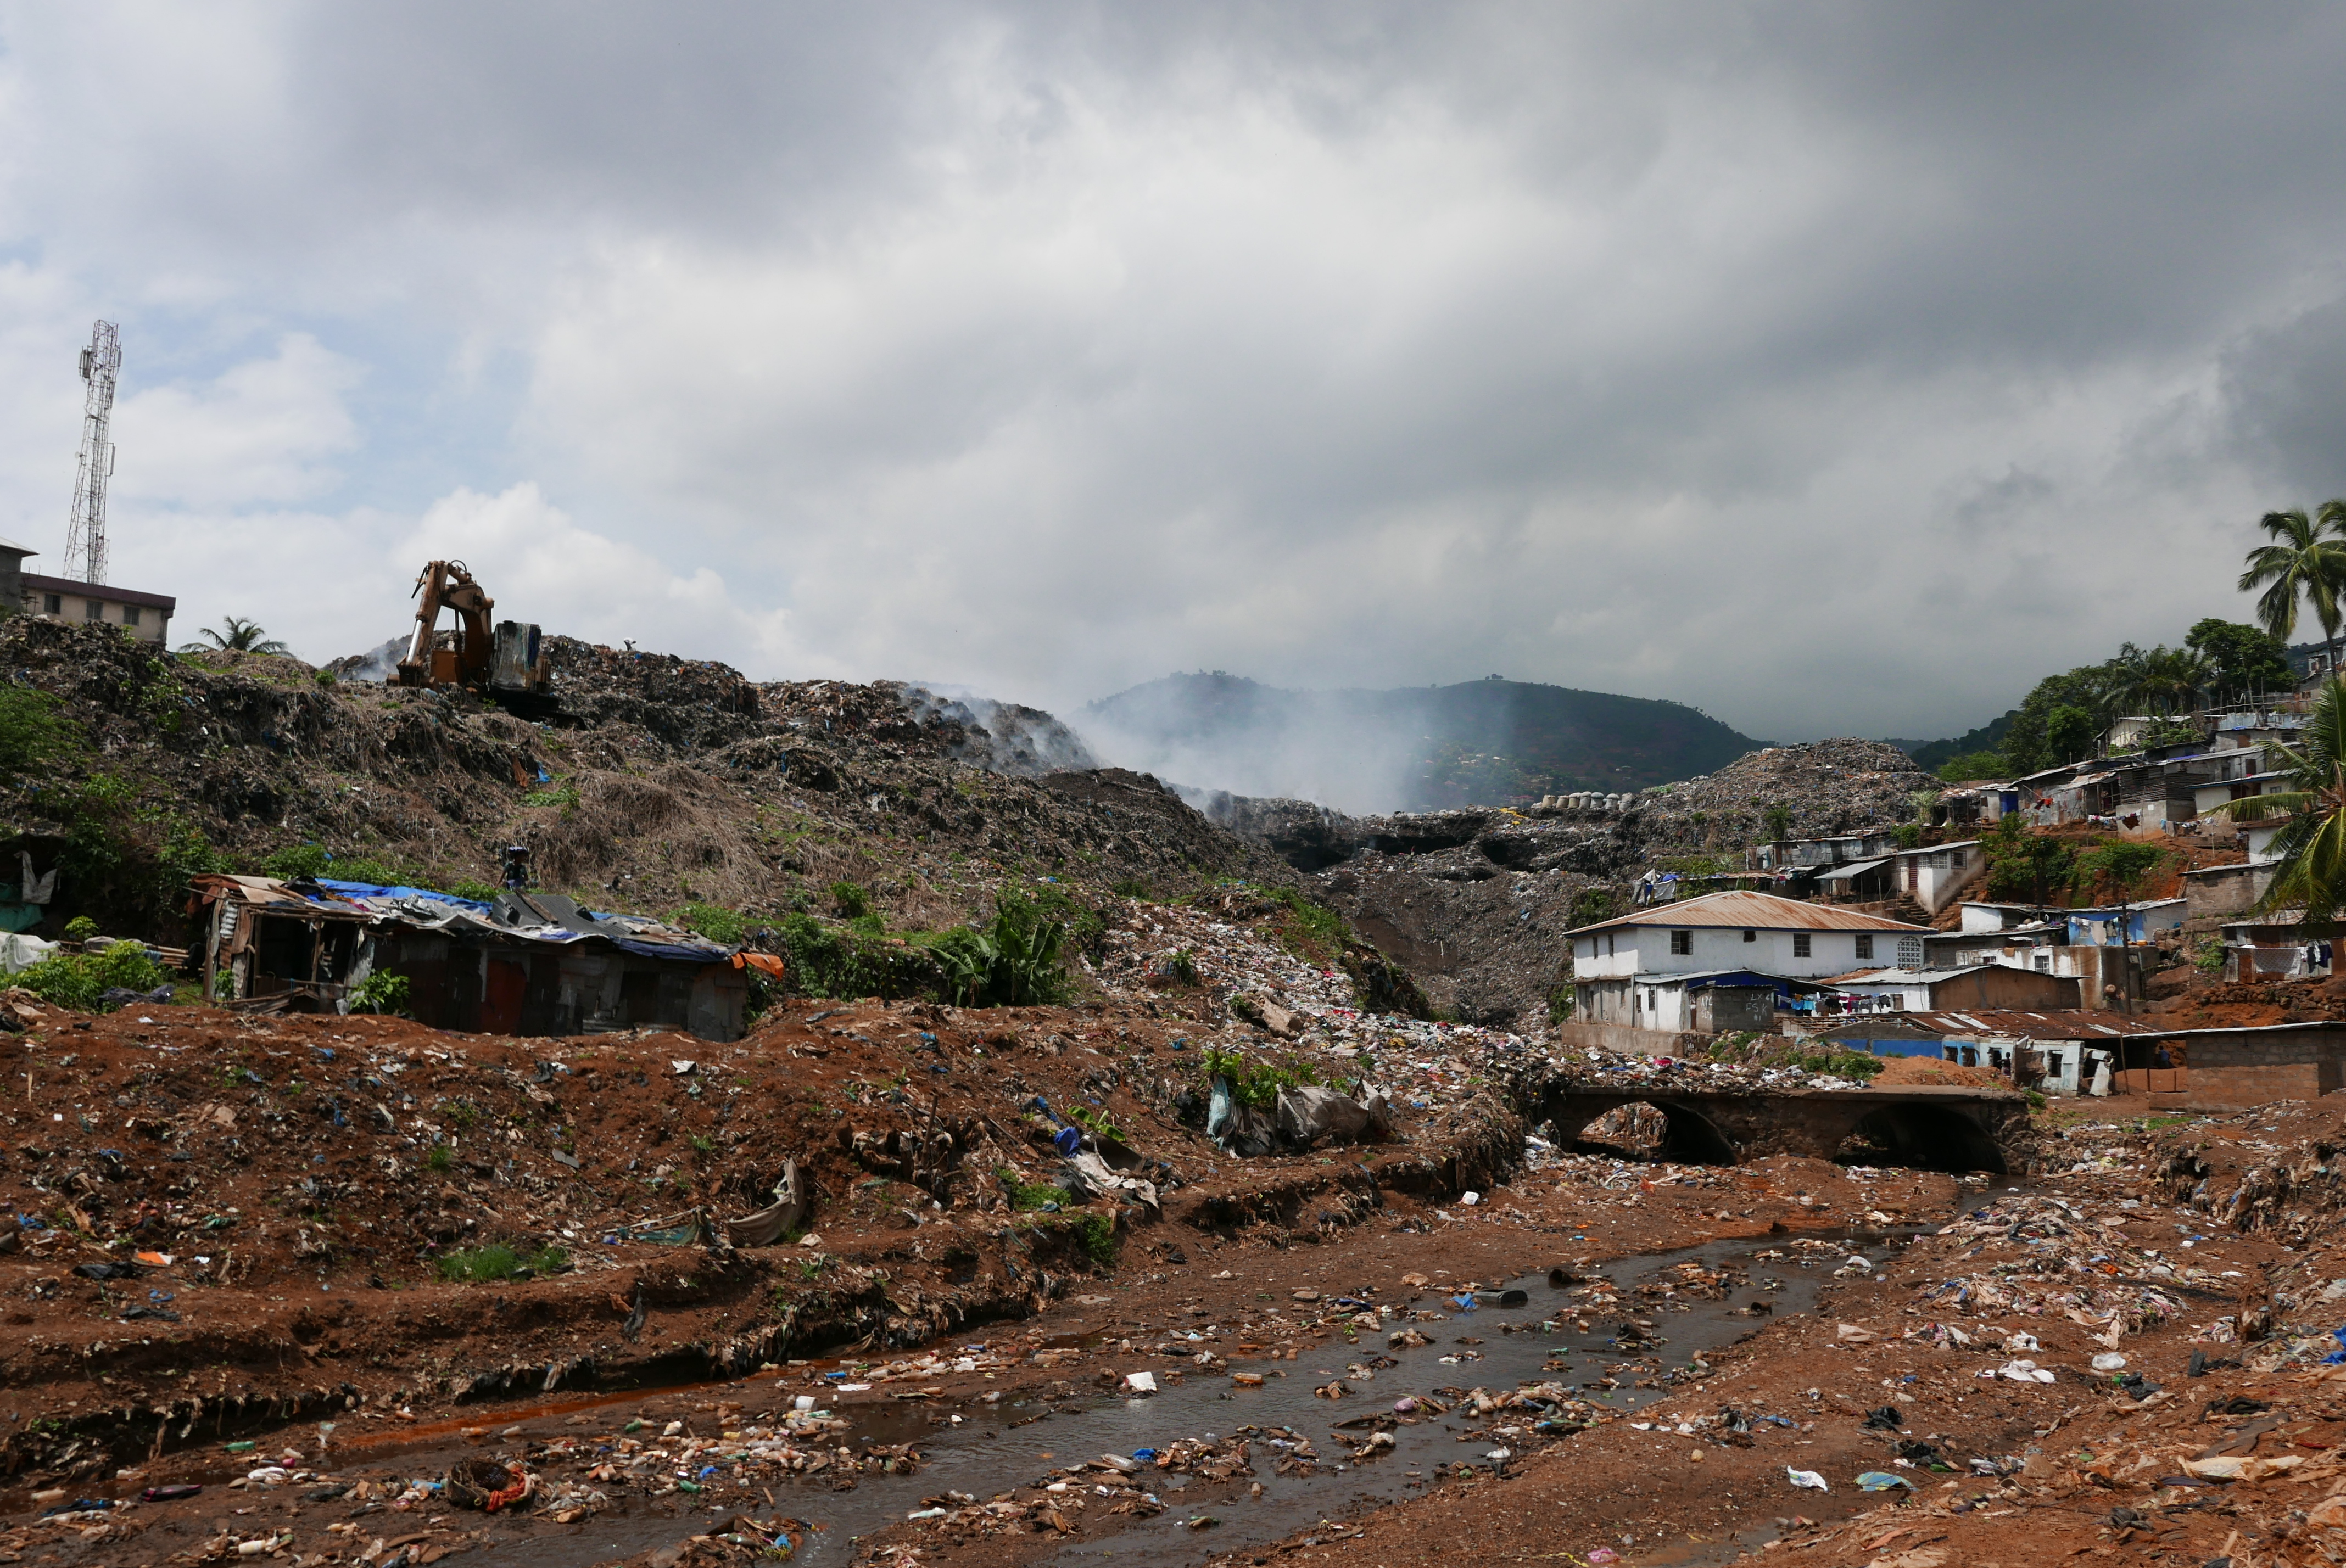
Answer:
0;617;1295;940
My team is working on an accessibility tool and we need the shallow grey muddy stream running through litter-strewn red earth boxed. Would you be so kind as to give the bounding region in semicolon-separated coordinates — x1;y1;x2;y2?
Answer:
261;1230;1905;1566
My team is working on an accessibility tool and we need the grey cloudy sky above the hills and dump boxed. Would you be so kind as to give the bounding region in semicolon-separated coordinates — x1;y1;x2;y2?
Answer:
0;0;2346;738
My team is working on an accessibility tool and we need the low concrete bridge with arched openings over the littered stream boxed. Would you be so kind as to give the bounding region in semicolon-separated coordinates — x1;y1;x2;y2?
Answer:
1532;1080;2029;1172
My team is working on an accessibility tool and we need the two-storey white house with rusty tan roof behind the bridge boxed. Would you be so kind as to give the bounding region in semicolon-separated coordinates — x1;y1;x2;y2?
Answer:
1565;893;1929;1029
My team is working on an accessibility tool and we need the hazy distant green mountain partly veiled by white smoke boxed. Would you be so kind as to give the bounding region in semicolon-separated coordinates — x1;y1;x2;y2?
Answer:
1081;670;1760;811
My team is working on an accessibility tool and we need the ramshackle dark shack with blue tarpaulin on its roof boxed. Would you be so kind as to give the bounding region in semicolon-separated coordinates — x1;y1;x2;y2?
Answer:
195;877;749;1040
